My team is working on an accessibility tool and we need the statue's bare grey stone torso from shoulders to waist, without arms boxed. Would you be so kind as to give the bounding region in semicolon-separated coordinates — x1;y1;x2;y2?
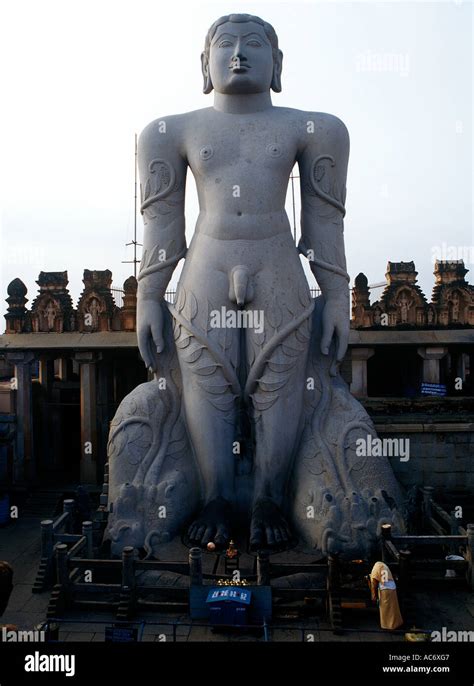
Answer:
184;108;304;239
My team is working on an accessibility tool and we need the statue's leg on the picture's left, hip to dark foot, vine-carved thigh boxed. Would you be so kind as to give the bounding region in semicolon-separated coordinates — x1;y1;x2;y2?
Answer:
172;274;240;547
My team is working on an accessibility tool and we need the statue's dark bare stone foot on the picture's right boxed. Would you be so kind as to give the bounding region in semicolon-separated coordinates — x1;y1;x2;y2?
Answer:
250;498;292;551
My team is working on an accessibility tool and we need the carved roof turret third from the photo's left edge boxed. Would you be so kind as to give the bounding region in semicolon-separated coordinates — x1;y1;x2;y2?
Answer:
76;269;118;332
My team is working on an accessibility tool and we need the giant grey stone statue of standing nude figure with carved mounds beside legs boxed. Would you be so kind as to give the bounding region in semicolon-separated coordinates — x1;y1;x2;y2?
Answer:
106;14;403;555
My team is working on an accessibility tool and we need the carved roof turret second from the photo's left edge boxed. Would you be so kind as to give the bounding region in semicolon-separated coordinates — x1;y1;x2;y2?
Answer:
31;271;74;333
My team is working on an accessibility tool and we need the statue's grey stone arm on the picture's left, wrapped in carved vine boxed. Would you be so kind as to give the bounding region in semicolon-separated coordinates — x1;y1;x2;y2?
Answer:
137;118;187;371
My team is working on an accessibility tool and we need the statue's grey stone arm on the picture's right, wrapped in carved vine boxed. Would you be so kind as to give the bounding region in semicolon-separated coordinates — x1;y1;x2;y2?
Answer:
298;114;349;368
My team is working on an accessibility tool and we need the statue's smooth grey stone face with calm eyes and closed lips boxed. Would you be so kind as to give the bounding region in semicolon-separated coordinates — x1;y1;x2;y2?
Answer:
208;22;274;94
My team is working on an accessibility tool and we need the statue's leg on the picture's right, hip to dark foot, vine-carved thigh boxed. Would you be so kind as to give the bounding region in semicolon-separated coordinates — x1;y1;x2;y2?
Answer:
246;265;313;550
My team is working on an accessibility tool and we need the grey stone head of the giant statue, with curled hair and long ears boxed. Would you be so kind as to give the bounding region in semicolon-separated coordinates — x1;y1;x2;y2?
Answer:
201;14;283;94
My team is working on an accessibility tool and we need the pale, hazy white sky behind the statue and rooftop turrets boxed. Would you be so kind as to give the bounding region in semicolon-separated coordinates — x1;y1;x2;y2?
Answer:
0;0;474;318
